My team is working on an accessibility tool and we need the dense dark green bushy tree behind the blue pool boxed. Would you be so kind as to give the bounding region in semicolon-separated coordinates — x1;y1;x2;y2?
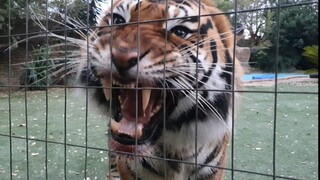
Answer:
252;1;318;71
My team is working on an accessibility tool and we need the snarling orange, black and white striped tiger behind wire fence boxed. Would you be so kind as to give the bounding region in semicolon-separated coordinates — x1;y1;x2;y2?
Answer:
77;0;242;180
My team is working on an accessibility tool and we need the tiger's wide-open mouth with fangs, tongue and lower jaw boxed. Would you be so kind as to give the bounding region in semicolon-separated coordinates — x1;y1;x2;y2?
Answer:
102;78;164;152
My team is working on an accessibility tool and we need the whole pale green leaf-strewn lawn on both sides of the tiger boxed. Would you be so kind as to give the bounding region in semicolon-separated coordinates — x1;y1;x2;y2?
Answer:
0;85;318;180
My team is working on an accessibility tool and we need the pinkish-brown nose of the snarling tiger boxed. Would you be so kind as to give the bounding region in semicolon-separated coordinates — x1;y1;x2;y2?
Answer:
111;50;138;74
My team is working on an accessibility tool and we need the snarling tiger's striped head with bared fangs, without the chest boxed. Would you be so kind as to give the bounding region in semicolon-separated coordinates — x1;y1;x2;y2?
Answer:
79;0;240;153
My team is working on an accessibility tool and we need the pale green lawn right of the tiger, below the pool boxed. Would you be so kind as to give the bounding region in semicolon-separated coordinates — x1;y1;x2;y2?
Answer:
228;85;319;180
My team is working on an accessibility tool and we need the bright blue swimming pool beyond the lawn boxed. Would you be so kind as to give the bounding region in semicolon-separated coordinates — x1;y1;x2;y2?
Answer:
242;73;308;81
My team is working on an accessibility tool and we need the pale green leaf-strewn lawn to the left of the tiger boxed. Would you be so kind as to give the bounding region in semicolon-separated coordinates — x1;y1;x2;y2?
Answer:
0;90;108;179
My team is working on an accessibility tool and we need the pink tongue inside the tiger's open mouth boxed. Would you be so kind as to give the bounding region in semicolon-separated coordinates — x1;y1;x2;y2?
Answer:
111;89;155;139
